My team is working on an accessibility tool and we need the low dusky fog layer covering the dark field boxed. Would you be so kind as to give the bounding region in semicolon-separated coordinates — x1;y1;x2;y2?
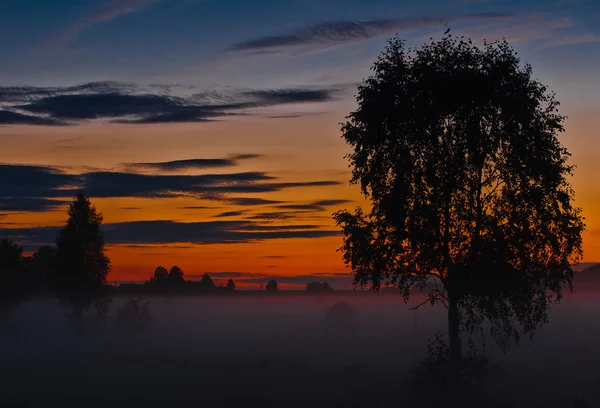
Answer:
0;291;600;407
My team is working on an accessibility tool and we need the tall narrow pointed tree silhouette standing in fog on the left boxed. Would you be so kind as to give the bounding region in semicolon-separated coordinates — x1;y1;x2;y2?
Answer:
54;193;110;325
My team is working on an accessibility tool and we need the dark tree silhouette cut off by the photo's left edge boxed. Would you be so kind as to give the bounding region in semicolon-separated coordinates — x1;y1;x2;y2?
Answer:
0;238;25;322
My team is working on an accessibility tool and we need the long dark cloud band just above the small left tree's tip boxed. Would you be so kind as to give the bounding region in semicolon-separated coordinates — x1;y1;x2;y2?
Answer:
0;164;340;205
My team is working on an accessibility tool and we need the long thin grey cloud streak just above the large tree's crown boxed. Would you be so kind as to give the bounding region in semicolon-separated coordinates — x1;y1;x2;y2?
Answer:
230;13;512;52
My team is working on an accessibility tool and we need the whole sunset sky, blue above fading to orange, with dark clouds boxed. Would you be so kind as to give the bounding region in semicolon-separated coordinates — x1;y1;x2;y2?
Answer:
0;0;600;287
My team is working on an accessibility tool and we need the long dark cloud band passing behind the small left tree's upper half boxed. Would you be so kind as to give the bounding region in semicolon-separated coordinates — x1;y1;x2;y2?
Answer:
0;220;340;247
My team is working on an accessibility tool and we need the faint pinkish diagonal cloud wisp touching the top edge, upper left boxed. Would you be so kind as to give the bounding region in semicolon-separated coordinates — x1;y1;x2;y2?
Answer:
47;0;161;44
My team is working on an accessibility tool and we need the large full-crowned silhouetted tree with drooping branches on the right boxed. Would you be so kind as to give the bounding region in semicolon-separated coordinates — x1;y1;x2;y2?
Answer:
334;32;585;378
